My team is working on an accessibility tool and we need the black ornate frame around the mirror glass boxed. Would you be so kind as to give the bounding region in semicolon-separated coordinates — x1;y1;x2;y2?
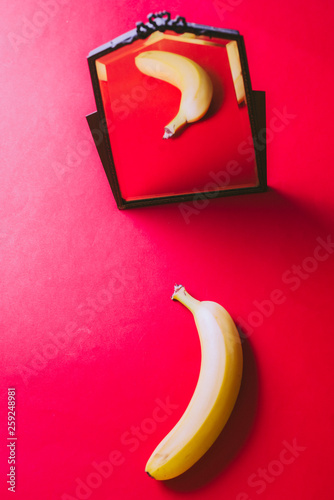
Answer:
86;11;267;209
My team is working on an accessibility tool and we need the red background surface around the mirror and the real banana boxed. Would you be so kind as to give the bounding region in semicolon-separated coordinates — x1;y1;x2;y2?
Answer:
0;0;334;500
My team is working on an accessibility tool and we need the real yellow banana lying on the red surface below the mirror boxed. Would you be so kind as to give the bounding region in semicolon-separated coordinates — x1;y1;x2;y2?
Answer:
145;285;243;480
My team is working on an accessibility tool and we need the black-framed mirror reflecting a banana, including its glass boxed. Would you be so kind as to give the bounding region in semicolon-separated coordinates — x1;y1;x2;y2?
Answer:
88;13;265;208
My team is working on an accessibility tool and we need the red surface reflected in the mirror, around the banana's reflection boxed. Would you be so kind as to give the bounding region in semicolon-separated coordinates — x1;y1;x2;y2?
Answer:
99;32;258;200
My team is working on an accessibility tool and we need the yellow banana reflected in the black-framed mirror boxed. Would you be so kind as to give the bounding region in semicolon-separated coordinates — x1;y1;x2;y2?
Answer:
135;50;213;139
